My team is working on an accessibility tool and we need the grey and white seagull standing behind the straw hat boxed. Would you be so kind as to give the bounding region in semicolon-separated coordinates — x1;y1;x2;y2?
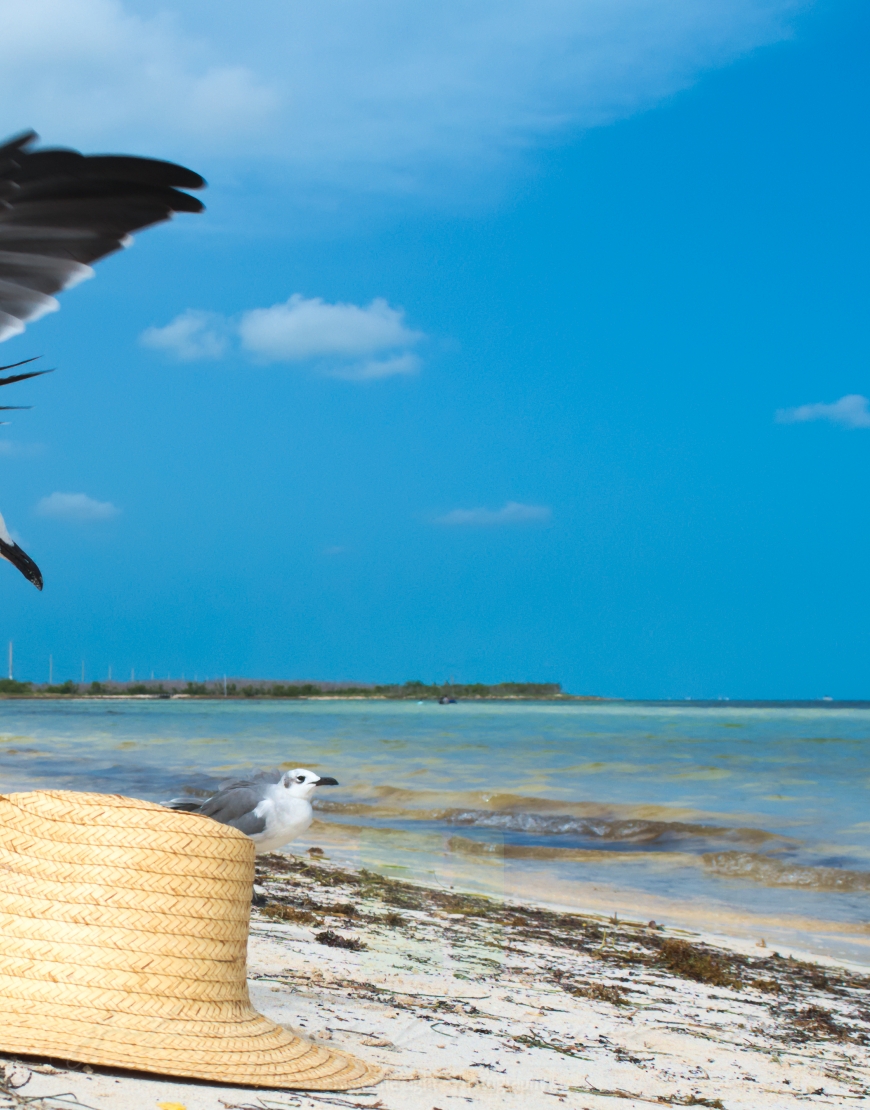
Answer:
168;767;338;856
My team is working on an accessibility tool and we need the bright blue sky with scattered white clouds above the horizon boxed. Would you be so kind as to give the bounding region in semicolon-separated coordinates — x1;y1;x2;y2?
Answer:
0;0;870;697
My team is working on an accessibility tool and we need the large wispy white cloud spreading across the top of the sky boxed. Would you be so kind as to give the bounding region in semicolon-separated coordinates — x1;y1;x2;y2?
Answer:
0;0;811;192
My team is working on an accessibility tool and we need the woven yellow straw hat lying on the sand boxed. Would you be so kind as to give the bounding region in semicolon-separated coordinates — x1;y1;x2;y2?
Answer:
0;790;380;1090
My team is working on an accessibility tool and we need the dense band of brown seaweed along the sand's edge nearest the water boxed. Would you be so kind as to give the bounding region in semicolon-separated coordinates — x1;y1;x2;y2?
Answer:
257;855;870;1043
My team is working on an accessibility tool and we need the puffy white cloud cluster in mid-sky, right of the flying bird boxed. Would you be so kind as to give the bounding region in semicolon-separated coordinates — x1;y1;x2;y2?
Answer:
140;293;425;382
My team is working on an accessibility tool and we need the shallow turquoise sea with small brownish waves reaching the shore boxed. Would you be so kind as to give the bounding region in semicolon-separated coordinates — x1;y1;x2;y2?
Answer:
0;699;870;963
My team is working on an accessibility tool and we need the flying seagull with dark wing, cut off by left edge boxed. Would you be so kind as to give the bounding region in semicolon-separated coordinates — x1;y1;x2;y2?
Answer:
0;131;205;589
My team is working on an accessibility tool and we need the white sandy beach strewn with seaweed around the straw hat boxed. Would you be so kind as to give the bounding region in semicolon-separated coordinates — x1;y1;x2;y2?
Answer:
0;855;870;1110
